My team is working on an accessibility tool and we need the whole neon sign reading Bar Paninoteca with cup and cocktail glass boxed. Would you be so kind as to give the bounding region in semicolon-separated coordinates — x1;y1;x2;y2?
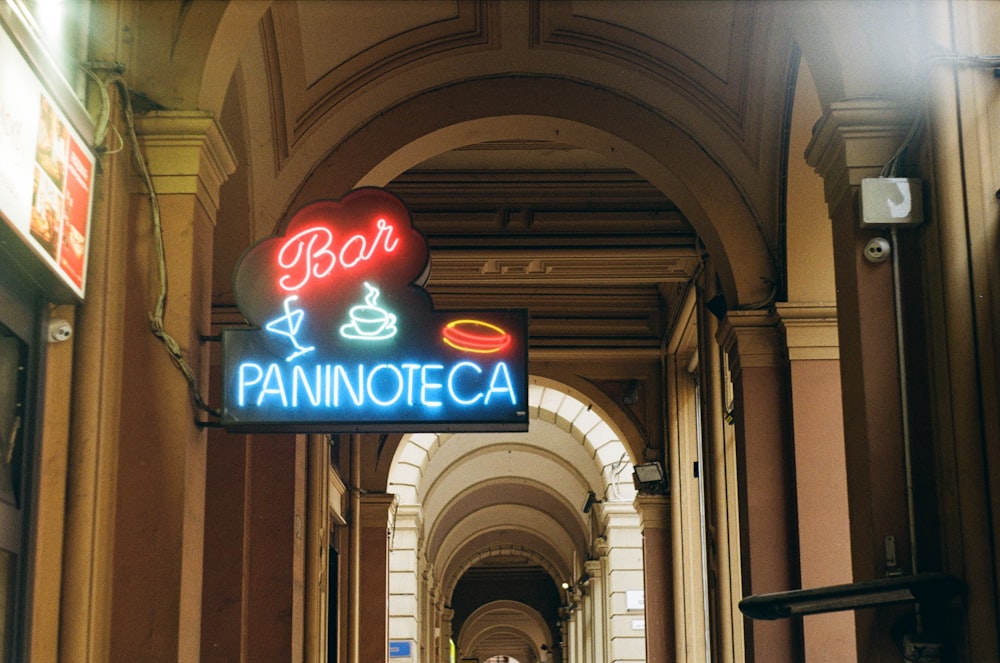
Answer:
222;188;527;432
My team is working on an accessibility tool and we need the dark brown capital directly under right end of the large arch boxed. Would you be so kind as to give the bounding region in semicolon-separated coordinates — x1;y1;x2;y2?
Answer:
715;309;786;375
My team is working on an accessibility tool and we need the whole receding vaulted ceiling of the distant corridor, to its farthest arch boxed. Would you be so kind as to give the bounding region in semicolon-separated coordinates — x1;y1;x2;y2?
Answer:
388;382;637;661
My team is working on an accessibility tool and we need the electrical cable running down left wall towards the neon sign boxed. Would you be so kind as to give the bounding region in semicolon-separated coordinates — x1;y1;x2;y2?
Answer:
81;62;221;418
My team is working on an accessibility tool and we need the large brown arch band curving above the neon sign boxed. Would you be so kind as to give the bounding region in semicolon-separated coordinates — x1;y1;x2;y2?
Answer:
285;76;777;306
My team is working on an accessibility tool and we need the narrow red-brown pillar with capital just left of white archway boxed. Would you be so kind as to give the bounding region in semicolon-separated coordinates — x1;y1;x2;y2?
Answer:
352;493;396;663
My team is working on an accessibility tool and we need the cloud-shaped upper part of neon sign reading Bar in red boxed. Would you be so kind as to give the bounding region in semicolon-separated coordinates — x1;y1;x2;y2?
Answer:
233;188;430;333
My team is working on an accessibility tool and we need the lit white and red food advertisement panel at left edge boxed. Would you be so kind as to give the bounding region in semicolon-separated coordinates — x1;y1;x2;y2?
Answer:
0;24;94;299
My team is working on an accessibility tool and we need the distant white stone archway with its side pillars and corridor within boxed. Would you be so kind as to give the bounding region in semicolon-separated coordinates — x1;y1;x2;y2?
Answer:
388;381;644;661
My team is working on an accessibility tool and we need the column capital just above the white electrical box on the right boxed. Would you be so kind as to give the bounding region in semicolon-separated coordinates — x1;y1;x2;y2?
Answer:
805;99;914;214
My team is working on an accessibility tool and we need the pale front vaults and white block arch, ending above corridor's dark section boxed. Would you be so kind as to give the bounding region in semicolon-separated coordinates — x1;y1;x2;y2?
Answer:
388;385;634;597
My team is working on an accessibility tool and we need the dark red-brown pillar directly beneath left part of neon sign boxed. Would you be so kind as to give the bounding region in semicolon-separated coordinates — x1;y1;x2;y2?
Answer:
199;431;308;663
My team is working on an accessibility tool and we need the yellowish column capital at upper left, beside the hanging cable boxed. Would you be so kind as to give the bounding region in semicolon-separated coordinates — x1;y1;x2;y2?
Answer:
135;111;236;219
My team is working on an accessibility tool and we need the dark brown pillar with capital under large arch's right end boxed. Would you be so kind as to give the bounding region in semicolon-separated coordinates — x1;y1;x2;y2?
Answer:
716;311;802;663
